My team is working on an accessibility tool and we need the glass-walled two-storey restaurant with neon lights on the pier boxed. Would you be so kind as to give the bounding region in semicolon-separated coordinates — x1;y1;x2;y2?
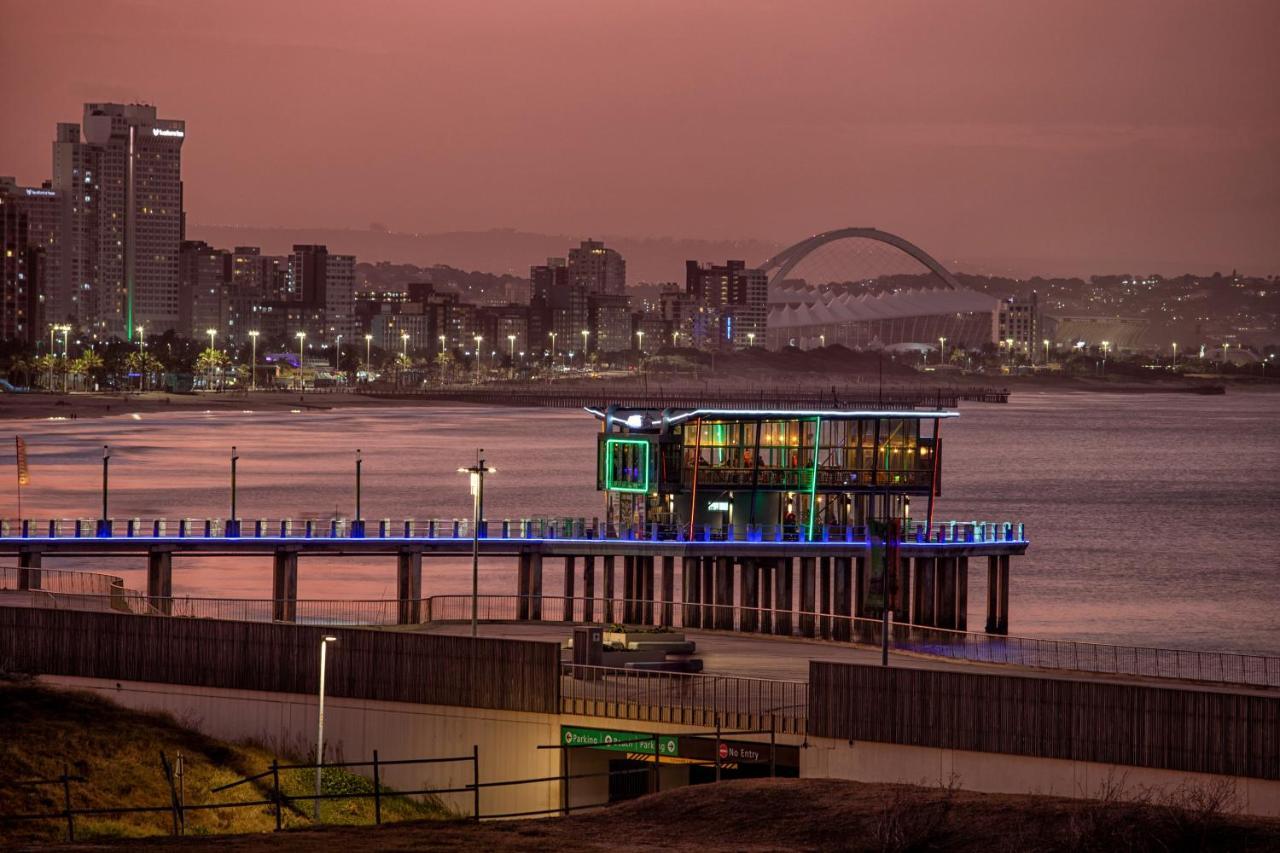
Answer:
589;409;956;539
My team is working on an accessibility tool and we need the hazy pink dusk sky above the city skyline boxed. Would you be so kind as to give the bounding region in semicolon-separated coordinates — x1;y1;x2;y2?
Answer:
0;0;1280;274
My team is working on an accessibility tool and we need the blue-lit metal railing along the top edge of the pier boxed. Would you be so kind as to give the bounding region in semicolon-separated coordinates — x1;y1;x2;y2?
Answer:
0;517;1027;544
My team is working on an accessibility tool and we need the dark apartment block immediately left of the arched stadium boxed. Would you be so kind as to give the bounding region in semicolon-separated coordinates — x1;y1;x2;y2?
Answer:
680;260;769;347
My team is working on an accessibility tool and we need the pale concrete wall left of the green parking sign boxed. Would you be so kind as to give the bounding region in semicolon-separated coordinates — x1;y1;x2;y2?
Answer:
40;676;561;816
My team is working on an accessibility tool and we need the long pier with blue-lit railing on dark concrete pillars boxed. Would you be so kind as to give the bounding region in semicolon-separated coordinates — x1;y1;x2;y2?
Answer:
0;519;1028;630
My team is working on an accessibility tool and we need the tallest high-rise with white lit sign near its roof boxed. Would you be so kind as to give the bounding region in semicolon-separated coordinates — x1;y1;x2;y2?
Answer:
75;104;187;339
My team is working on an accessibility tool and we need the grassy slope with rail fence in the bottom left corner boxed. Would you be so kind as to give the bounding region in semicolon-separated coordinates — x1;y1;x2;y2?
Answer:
0;684;454;848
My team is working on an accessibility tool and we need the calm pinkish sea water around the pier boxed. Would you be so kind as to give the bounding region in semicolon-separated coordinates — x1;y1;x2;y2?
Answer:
0;393;1280;653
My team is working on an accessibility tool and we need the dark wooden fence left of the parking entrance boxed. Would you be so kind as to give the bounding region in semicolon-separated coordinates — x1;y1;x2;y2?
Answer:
0;607;559;713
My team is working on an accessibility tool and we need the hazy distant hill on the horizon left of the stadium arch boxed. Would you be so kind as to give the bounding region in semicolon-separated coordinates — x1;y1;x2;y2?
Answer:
187;225;783;284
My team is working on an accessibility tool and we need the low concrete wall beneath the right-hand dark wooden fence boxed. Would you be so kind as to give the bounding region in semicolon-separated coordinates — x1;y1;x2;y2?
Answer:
800;736;1280;817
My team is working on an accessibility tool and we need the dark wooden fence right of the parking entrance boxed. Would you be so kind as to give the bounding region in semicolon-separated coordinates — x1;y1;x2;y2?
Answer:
809;661;1280;779
